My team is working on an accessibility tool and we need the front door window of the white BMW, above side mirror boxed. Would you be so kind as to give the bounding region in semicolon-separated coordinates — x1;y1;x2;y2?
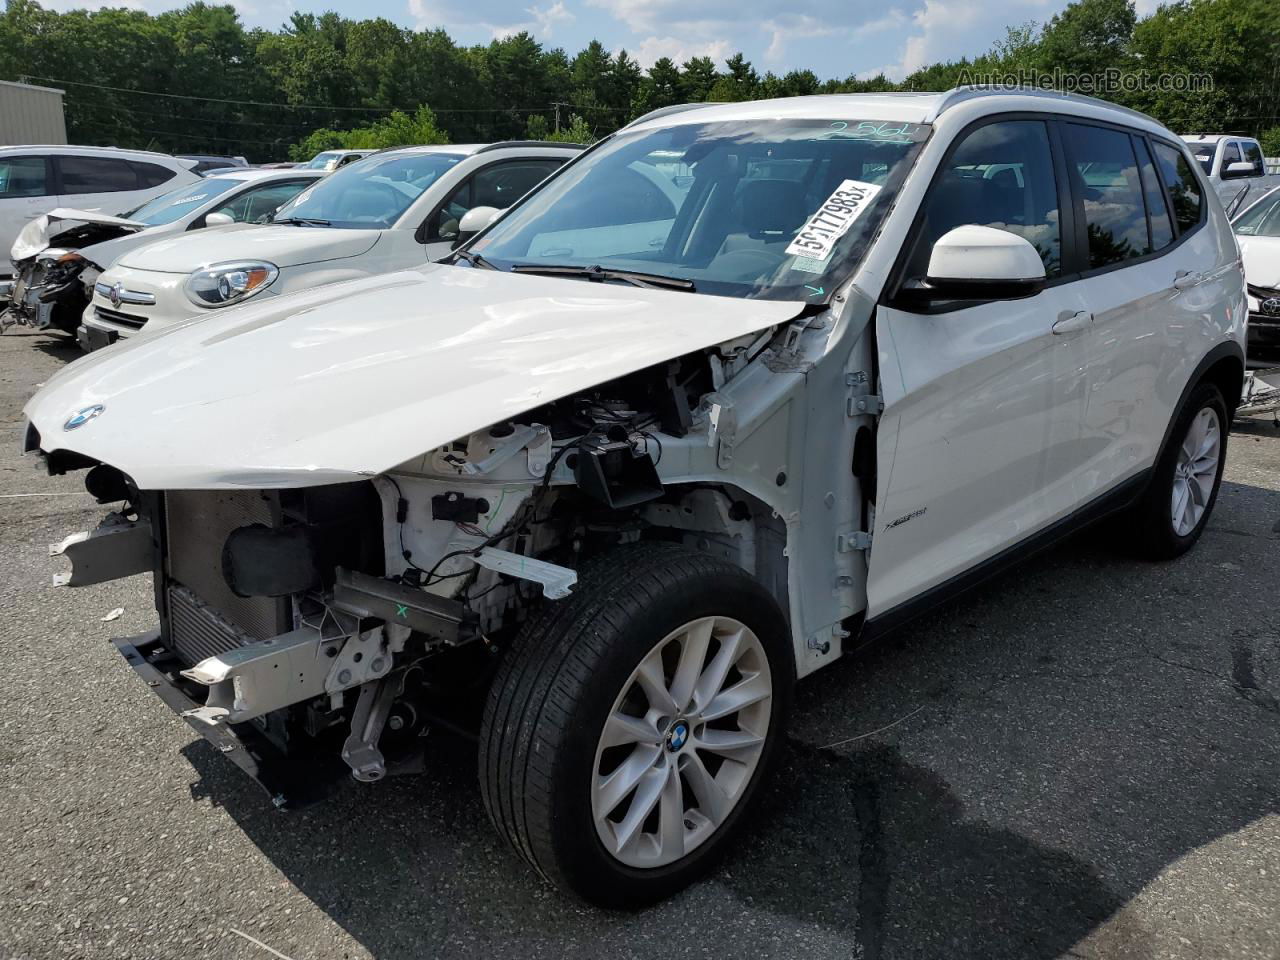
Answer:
908;120;1062;278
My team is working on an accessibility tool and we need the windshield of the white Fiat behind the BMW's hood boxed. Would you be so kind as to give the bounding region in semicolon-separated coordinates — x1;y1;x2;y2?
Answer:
275;154;462;229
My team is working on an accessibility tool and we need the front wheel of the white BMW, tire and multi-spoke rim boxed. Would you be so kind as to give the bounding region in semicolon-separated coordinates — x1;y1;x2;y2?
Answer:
480;544;795;906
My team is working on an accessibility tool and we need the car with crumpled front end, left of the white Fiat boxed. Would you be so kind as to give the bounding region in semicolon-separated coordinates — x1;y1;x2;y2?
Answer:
0;168;325;349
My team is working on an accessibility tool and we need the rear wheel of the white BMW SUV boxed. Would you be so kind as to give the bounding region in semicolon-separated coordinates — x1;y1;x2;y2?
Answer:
1129;383;1230;561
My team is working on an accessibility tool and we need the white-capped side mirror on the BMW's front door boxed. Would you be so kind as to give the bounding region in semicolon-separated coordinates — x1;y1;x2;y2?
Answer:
913;224;1044;300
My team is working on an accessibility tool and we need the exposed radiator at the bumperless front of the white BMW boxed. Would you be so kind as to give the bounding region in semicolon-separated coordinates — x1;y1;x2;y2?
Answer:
165;490;289;663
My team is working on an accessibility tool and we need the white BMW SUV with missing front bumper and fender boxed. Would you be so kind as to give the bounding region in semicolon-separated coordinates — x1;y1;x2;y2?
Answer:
26;90;1245;905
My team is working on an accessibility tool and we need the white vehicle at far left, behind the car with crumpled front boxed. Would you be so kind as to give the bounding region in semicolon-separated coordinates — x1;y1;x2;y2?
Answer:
0;146;200;284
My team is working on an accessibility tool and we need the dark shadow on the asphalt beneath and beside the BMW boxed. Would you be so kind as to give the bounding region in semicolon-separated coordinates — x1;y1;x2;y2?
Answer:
177;484;1280;960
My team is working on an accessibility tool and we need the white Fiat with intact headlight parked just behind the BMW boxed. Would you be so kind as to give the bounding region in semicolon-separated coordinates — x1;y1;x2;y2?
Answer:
83;141;581;337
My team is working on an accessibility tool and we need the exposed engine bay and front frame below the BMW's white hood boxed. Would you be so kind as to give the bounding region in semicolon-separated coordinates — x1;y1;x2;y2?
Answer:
37;317;870;805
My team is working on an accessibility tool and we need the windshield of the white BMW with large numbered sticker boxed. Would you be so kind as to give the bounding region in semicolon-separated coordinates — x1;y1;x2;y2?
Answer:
471;119;929;300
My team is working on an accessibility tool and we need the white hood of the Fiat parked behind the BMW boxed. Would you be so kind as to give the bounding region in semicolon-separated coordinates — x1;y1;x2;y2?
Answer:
119;224;378;274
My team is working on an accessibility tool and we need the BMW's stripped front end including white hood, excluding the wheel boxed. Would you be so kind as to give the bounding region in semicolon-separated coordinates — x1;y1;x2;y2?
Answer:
27;268;858;805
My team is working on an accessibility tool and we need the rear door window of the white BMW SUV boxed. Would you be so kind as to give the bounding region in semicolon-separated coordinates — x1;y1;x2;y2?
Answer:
1065;123;1151;270
